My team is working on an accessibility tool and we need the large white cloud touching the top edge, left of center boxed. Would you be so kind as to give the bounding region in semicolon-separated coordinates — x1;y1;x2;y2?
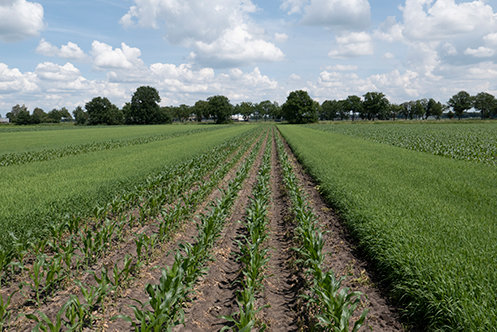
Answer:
120;0;284;68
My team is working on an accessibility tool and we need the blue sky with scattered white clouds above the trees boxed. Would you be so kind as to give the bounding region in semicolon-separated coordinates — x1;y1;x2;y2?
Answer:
0;0;497;116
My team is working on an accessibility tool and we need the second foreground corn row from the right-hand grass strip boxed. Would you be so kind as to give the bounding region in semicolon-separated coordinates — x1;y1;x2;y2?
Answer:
221;132;272;331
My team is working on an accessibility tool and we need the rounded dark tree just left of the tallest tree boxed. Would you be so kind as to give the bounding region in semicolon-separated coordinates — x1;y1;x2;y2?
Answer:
85;97;123;125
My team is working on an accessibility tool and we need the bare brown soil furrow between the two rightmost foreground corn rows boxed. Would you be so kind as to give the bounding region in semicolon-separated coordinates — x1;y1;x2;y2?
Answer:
258;131;302;332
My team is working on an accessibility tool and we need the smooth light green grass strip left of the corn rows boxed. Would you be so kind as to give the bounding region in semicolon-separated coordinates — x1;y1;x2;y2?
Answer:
0;127;251;247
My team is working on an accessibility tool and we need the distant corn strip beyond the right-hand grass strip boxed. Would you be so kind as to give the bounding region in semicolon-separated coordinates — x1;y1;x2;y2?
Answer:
310;124;497;166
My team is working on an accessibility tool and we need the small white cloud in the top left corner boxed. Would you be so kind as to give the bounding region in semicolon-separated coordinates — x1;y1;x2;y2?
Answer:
0;0;45;42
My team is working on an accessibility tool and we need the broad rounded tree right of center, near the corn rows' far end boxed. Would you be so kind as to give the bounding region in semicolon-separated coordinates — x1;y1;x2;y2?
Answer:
281;90;319;123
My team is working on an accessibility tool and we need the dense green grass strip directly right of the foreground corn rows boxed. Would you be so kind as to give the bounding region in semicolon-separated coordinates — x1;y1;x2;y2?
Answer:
278;124;497;331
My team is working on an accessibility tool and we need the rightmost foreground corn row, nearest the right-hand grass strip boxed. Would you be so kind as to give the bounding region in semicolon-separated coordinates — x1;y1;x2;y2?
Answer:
276;131;368;332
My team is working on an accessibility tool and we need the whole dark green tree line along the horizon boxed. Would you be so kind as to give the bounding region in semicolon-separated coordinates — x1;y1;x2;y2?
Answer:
6;86;497;125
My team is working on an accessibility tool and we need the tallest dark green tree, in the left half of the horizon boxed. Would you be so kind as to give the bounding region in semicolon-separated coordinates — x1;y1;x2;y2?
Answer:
125;86;164;124
